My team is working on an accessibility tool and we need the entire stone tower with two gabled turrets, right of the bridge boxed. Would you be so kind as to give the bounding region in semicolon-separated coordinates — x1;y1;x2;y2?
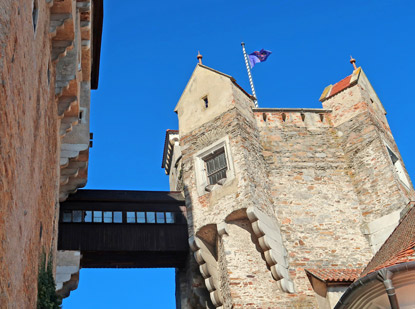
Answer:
163;64;414;308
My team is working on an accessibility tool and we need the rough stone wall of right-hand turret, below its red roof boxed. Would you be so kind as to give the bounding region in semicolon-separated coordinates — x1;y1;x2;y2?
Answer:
323;81;415;222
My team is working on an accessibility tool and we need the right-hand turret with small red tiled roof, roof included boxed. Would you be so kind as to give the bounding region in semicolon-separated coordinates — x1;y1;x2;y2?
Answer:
320;66;415;253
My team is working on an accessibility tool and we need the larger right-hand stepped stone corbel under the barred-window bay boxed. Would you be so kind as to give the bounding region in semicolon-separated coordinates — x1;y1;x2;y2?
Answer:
246;207;295;293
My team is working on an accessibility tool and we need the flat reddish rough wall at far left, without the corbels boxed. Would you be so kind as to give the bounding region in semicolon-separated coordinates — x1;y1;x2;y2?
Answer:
0;0;59;308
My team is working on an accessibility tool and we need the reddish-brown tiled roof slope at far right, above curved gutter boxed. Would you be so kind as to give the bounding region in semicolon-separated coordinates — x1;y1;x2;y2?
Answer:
361;202;415;277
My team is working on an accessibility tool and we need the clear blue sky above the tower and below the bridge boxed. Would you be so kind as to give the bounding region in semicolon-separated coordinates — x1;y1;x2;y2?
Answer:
64;0;415;309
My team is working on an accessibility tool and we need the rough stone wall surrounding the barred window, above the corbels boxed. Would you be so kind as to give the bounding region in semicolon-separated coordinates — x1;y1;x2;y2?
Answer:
181;109;271;236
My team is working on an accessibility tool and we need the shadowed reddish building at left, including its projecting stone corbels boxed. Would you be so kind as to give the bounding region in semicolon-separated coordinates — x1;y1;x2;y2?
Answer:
0;0;102;308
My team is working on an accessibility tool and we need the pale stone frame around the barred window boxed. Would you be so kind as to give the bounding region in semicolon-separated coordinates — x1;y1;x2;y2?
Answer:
193;136;235;196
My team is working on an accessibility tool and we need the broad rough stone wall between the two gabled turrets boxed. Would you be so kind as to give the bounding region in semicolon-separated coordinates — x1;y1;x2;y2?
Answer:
255;112;371;307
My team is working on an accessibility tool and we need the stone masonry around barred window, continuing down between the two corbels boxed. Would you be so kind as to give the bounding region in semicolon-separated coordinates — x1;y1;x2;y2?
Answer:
180;91;294;308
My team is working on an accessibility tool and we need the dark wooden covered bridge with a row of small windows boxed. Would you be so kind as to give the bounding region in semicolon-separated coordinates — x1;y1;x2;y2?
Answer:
58;190;189;268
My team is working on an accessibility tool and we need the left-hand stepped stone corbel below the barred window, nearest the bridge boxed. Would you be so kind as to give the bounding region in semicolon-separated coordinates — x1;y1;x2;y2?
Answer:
189;236;223;308
